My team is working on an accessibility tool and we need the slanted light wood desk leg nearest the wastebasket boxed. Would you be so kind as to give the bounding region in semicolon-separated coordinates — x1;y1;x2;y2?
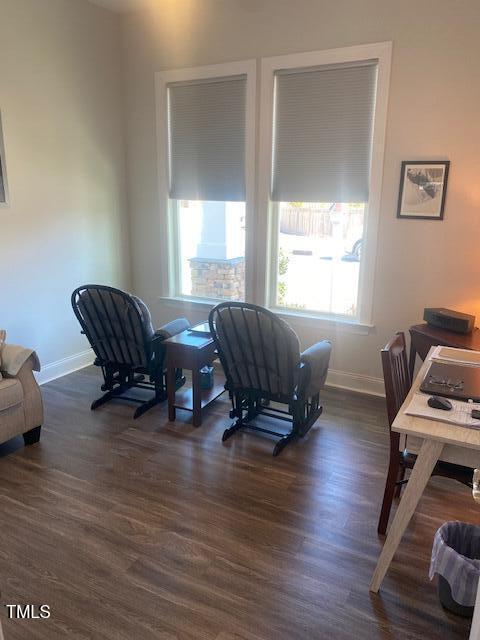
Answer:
370;440;443;593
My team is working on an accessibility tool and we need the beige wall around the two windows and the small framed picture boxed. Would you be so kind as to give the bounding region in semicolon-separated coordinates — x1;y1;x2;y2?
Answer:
123;0;480;389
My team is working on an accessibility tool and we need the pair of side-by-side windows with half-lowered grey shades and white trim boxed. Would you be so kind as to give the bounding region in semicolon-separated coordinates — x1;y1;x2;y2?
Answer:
156;43;391;331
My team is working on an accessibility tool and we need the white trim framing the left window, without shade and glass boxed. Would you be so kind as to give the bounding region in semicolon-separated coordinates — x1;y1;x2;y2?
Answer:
155;59;256;305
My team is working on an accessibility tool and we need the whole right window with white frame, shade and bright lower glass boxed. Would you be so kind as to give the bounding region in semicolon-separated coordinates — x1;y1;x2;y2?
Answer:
262;44;390;323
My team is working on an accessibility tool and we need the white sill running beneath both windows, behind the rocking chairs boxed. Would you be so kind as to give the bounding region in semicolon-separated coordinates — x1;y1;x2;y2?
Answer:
159;296;375;336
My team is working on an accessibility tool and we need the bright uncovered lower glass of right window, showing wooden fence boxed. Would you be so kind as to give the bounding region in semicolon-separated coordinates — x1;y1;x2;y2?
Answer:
272;202;365;318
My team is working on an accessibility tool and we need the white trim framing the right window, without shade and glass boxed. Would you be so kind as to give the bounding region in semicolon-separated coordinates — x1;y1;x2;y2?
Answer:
255;42;392;327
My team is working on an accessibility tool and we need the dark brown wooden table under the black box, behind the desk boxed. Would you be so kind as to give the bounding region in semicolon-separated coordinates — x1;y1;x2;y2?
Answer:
408;324;480;380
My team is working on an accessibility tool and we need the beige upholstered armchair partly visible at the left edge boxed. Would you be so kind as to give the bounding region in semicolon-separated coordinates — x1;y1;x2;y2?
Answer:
0;331;43;444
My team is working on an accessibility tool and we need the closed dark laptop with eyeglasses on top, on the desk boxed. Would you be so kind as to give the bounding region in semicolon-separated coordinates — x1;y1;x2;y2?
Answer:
420;362;480;402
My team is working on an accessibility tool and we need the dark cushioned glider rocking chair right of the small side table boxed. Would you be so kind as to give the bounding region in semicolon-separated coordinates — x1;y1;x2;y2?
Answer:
209;302;331;456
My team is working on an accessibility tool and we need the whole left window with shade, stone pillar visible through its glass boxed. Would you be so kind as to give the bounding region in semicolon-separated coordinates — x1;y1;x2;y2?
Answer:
160;62;254;300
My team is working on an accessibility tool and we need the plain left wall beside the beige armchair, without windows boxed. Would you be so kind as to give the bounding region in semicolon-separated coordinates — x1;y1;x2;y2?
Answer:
0;0;130;373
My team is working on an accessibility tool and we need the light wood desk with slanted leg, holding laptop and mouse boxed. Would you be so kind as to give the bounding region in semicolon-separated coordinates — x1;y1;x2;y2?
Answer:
370;347;480;593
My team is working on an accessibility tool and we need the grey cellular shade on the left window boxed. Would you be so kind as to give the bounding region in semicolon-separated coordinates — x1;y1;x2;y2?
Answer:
167;75;247;201
